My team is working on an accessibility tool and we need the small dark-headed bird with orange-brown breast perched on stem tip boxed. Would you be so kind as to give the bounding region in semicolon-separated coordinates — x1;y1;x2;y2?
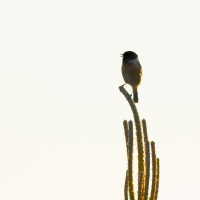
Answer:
121;51;142;103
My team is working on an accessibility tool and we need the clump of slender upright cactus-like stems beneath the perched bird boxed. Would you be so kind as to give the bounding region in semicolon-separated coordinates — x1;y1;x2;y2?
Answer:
119;86;160;200
